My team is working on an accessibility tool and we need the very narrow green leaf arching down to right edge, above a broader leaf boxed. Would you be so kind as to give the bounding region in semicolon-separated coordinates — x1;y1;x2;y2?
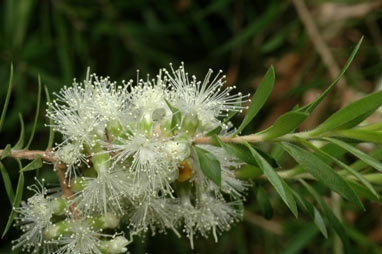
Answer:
298;138;379;198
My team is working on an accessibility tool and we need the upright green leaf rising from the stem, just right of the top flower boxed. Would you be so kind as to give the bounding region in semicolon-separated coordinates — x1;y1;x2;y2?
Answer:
233;66;275;136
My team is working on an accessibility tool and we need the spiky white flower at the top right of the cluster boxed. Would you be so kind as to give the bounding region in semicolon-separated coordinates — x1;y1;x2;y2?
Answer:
164;63;248;131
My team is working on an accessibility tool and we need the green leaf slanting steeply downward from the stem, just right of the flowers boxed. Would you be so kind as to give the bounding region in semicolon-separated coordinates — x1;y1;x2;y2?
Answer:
244;141;298;217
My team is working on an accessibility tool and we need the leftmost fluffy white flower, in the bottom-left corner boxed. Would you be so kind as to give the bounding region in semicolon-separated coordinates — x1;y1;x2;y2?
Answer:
12;181;55;253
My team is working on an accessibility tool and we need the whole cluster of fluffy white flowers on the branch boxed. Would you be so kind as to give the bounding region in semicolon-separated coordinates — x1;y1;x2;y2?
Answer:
11;64;248;254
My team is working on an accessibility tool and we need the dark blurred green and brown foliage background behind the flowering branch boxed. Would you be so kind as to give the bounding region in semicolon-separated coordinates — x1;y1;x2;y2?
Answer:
0;0;382;254
